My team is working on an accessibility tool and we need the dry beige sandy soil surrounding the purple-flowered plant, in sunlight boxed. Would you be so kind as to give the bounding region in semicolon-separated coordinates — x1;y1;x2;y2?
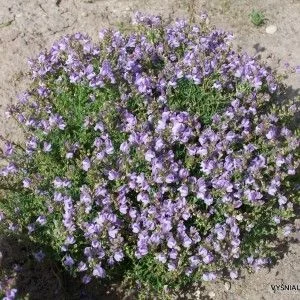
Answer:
0;0;300;300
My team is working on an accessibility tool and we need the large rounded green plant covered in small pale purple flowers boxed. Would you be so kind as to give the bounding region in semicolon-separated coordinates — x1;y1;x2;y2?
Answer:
0;14;299;298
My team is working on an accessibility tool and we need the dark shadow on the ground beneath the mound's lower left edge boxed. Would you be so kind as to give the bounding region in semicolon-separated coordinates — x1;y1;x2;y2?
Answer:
0;237;120;300
